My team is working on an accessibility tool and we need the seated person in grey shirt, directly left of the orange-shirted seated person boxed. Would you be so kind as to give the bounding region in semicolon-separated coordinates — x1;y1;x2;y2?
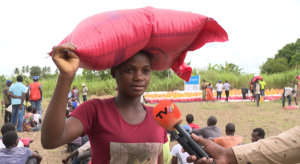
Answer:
192;116;222;139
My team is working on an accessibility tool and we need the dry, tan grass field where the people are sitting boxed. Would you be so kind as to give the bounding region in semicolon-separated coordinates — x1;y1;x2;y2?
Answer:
0;96;300;164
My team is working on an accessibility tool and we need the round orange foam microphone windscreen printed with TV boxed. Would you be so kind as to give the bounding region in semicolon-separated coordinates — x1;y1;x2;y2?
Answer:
153;100;182;131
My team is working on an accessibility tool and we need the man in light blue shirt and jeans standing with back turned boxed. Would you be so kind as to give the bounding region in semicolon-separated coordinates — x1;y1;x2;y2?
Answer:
9;75;26;132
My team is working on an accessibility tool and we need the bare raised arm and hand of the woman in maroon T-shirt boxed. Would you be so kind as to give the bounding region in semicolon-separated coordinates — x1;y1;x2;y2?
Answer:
41;43;84;149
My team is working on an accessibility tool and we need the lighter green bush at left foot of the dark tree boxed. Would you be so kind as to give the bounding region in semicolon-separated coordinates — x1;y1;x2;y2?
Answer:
259;58;290;74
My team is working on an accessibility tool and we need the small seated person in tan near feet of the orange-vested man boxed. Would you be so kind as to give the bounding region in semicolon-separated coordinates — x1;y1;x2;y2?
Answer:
23;106;40;132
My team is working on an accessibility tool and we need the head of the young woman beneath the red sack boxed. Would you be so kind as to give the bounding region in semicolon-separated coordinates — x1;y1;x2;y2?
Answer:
111;51;151;97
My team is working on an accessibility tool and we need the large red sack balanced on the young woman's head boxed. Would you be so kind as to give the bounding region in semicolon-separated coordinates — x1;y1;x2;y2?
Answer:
50;7;228;81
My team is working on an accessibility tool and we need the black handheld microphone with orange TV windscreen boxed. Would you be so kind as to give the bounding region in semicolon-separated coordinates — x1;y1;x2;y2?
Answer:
153;100;215;164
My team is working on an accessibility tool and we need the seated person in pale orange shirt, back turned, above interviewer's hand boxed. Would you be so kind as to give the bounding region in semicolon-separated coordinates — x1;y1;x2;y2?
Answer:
210;123;243;148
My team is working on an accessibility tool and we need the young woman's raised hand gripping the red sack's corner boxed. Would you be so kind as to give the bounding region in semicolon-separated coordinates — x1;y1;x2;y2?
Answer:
52;43;80;75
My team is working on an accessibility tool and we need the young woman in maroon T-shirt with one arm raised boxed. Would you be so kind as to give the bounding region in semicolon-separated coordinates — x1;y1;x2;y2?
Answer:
41;43;168;164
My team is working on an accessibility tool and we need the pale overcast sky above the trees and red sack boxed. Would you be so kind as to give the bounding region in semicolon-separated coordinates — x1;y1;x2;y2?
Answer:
0;0;300;75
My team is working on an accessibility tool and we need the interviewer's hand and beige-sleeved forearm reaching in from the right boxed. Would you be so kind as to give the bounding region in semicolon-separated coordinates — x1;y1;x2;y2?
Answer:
183;126;300;164
